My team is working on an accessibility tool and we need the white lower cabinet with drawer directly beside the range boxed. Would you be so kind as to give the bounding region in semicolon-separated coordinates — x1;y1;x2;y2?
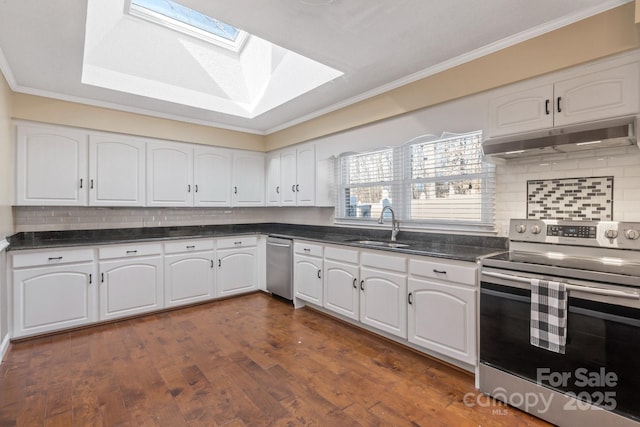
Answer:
408;259;477;365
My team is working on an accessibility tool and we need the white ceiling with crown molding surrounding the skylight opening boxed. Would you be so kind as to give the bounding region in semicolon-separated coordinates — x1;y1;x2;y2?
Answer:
0;0;630;134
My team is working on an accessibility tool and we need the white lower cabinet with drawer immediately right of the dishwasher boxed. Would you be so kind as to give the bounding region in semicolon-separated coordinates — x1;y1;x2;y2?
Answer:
293;241;323;306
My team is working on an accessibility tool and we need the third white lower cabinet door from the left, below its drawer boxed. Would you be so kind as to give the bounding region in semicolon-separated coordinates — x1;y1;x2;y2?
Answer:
164;251;215;307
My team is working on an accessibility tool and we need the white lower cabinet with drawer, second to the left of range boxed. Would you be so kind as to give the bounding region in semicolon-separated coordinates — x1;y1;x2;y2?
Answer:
360;252;407;338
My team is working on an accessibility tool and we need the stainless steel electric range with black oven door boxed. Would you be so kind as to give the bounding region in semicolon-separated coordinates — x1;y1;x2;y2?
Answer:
478;220;640;427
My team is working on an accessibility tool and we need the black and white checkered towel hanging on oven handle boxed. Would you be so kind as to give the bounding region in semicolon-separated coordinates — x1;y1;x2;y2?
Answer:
531;279;568;354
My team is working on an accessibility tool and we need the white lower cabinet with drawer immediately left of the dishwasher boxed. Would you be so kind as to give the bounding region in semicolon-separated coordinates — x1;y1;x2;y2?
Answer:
216;236;258;297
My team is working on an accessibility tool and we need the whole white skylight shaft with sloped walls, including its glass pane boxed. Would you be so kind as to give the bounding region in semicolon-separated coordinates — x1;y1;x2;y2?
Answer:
86;0;342;118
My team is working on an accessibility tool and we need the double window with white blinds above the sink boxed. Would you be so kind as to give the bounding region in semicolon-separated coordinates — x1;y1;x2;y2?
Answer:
336;132;495;230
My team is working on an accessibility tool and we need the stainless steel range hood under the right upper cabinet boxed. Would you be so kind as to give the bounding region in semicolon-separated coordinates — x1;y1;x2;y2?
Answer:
482;116;638;159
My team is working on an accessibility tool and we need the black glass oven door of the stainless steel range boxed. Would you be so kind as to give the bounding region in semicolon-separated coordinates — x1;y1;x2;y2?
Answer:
480;268;640;420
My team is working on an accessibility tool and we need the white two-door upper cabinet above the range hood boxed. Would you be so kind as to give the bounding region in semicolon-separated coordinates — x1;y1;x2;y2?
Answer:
489;63;640;137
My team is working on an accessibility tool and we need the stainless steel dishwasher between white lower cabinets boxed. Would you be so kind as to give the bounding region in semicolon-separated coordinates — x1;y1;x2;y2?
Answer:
267;237;293;301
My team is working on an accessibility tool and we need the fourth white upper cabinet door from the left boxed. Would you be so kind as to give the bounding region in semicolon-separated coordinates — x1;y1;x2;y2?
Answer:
193;148;231;206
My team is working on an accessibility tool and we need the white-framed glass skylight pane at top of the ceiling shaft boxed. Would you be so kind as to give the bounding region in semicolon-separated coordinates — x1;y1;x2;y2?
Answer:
129;0;247;52
